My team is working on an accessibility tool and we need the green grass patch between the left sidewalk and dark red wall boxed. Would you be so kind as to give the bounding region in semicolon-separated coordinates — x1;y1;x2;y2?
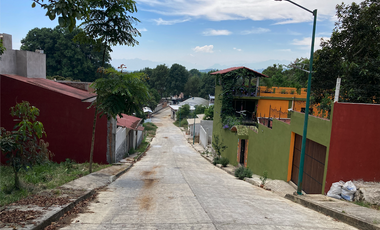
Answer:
0;160;111;206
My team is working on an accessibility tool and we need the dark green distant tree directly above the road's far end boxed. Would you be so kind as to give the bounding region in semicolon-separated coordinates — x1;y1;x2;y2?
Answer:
149;64;169;97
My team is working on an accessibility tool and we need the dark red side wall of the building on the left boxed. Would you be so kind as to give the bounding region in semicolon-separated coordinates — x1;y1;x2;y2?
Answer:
0;76;107;163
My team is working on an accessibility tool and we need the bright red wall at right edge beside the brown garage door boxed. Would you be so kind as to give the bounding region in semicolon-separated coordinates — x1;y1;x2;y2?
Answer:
325;103;380;192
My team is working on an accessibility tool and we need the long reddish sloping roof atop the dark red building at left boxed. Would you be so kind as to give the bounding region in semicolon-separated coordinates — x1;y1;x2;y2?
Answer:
0;74;96;101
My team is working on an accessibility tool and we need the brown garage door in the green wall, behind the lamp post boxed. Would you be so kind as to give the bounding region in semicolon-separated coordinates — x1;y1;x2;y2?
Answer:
291;134;326;194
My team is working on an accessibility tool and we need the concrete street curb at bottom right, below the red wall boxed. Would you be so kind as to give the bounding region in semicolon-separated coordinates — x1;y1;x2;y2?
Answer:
285;194;380;230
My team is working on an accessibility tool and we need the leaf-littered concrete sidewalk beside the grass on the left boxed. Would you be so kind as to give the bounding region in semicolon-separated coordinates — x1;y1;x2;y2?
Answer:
0;150;143;230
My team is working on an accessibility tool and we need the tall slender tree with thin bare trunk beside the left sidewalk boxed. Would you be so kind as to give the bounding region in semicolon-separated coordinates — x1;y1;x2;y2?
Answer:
74;0;142;173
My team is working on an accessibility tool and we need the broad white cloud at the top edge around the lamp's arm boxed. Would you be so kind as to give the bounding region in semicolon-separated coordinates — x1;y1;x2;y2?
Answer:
138;0;361;24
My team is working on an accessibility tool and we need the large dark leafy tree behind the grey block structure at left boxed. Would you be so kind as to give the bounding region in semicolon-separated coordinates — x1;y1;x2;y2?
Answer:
21;26;111;82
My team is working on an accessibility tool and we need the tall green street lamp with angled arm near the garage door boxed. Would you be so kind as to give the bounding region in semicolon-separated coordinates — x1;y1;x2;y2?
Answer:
275;0;317;195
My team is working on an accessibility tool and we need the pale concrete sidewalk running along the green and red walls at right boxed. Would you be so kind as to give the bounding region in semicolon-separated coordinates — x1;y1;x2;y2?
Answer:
189;138;380;230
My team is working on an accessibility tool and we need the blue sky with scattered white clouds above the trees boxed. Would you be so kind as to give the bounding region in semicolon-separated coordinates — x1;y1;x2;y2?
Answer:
0;0;360;71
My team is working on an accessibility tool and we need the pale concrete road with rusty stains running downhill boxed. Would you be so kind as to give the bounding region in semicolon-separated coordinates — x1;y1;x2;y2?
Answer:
64;110;355;229
